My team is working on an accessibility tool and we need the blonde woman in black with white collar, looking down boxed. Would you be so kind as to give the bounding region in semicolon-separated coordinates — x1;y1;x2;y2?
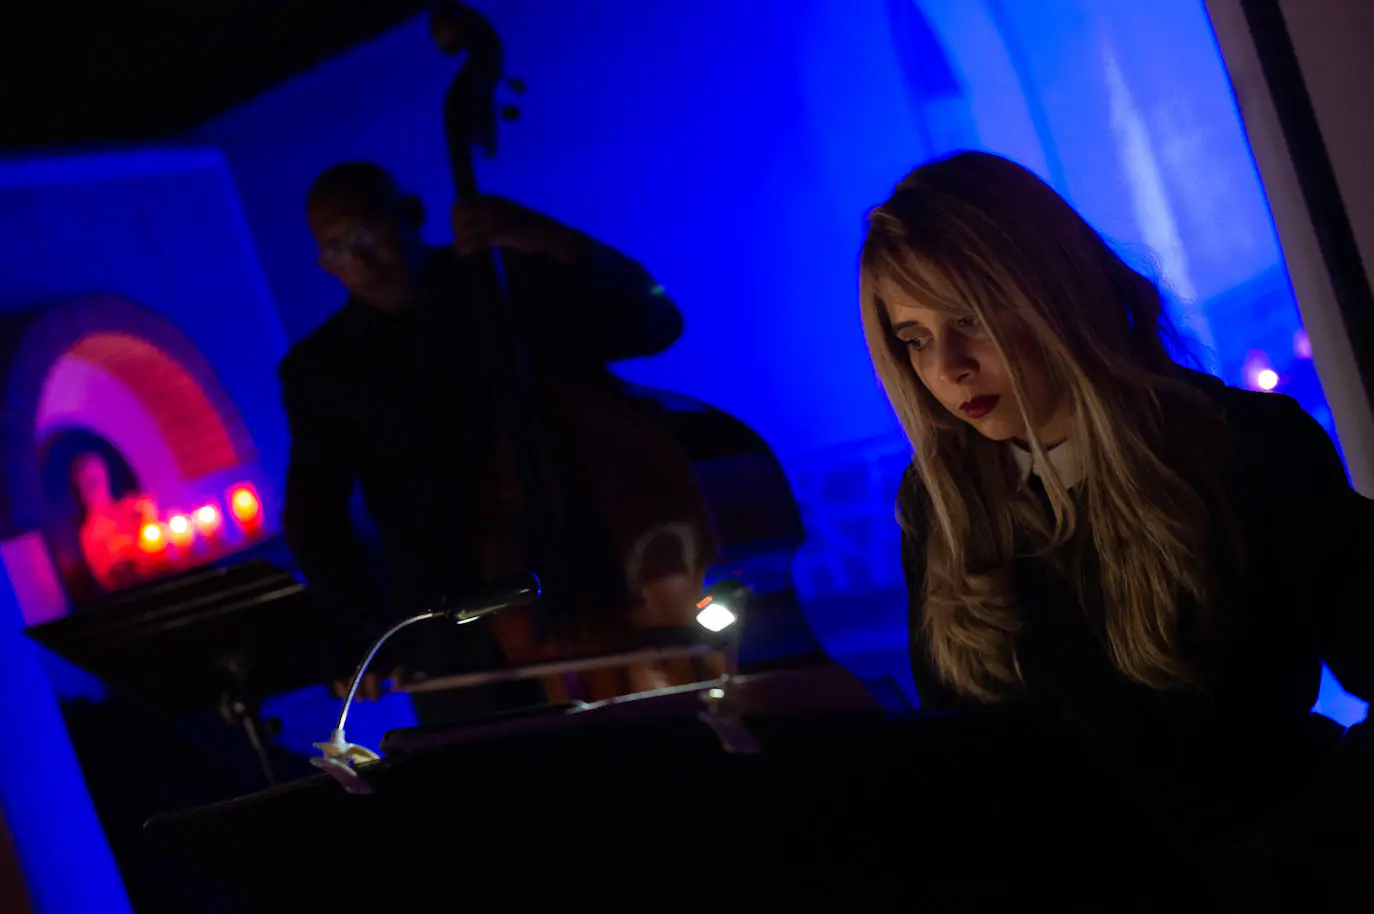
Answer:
861;153;1374;857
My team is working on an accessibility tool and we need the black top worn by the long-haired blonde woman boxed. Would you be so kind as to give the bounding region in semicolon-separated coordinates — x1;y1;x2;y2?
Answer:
903;377;1374;833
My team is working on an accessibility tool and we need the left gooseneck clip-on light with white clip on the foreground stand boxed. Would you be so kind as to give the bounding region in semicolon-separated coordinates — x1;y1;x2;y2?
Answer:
311;573;543;794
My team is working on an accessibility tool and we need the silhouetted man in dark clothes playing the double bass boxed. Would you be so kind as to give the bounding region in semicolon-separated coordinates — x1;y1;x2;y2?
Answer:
280;162;682;709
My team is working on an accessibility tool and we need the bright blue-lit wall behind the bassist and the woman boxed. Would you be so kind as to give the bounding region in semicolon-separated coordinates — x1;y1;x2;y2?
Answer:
198;0;1349;719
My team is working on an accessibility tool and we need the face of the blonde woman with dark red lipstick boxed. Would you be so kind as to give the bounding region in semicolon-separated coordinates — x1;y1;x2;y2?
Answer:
883;296;1069;447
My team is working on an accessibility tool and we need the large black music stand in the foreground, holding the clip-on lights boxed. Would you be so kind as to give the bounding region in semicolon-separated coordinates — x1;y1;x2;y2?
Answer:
144;692;1198;911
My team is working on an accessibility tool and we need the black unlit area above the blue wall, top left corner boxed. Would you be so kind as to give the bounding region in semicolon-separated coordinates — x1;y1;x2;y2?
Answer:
0;0;429;150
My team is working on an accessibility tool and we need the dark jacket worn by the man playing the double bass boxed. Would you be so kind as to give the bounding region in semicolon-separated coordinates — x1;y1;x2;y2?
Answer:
280;239;682;645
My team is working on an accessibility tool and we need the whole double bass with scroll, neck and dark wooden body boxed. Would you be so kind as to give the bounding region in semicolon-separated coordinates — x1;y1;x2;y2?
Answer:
430;1;802;702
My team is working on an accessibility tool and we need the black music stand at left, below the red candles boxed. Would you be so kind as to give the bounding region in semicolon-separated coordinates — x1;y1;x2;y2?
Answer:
26;561;345;785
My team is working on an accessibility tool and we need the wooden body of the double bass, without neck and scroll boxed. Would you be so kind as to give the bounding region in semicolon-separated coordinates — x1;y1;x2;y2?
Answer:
480;376;802;701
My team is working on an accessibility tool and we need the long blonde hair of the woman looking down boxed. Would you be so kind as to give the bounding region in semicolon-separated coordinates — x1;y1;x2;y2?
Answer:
860;153;1236;702
